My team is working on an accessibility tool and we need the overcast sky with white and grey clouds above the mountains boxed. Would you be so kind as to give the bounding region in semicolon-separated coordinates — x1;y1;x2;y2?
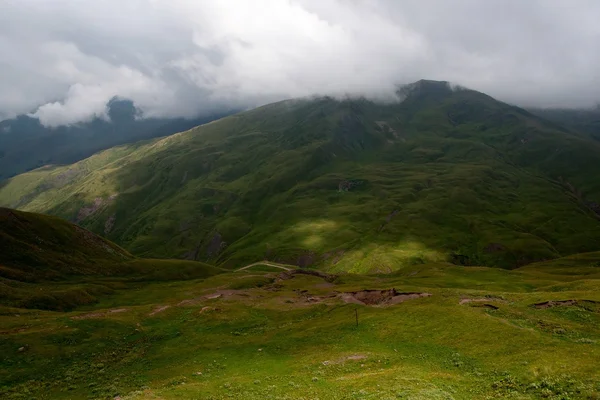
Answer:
0;0;600;125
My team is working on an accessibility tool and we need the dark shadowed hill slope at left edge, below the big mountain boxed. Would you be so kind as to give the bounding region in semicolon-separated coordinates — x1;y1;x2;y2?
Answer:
0;208;221;310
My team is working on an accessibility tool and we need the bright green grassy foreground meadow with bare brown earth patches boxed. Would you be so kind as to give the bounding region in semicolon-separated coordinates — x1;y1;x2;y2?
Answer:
0;253;600;400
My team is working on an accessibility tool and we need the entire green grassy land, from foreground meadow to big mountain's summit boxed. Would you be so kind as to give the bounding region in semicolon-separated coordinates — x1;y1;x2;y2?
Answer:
0;81;600;400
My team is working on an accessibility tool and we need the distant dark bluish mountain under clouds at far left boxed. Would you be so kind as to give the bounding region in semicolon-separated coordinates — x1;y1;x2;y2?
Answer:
0;99;234;181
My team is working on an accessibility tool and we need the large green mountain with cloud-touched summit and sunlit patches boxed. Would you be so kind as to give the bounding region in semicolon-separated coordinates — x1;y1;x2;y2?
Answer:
0;81;600;272
